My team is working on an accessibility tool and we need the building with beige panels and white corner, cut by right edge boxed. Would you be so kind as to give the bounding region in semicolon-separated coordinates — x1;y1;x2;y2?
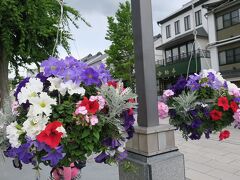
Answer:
204;0;240;86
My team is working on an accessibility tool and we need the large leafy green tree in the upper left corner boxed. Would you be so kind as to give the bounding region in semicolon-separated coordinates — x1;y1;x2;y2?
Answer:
0;0;84;107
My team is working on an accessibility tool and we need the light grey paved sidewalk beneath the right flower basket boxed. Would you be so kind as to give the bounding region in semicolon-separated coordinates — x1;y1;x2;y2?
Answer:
175;127;240;180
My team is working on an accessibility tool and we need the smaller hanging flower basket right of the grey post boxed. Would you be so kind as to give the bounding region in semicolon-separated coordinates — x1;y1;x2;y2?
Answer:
158;70;240;140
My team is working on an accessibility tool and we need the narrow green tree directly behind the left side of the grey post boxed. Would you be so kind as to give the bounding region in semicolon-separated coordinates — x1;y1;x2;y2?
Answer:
105;1;134;87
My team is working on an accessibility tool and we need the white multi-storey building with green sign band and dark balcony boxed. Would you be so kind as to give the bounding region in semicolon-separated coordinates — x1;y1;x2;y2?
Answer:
157;0;211;92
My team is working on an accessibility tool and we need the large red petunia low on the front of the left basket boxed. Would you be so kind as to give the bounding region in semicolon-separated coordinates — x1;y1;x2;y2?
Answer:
37;121;63;148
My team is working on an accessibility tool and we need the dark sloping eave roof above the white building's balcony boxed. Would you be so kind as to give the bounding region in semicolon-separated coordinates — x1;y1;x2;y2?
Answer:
156;27;208;50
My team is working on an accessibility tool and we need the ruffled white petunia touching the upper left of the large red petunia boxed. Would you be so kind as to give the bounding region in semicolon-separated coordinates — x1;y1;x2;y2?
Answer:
22;116;48;140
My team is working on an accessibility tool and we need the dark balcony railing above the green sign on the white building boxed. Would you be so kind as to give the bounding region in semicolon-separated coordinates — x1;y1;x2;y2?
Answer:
156;49;210;66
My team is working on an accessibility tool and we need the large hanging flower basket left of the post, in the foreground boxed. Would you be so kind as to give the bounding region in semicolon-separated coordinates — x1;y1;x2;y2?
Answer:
0;57;136;180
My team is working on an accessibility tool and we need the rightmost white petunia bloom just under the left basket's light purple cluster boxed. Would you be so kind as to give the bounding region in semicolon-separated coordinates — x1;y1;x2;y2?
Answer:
61;80;85;96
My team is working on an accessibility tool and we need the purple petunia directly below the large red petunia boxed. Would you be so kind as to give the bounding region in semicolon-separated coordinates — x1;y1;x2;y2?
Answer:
41;146;64;167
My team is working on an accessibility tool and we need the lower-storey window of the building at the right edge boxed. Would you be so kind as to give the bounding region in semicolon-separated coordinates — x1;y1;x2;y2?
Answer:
219;47;240;65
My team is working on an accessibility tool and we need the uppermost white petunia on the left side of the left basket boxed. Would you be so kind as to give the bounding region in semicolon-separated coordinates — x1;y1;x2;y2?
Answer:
17;78;43;104
